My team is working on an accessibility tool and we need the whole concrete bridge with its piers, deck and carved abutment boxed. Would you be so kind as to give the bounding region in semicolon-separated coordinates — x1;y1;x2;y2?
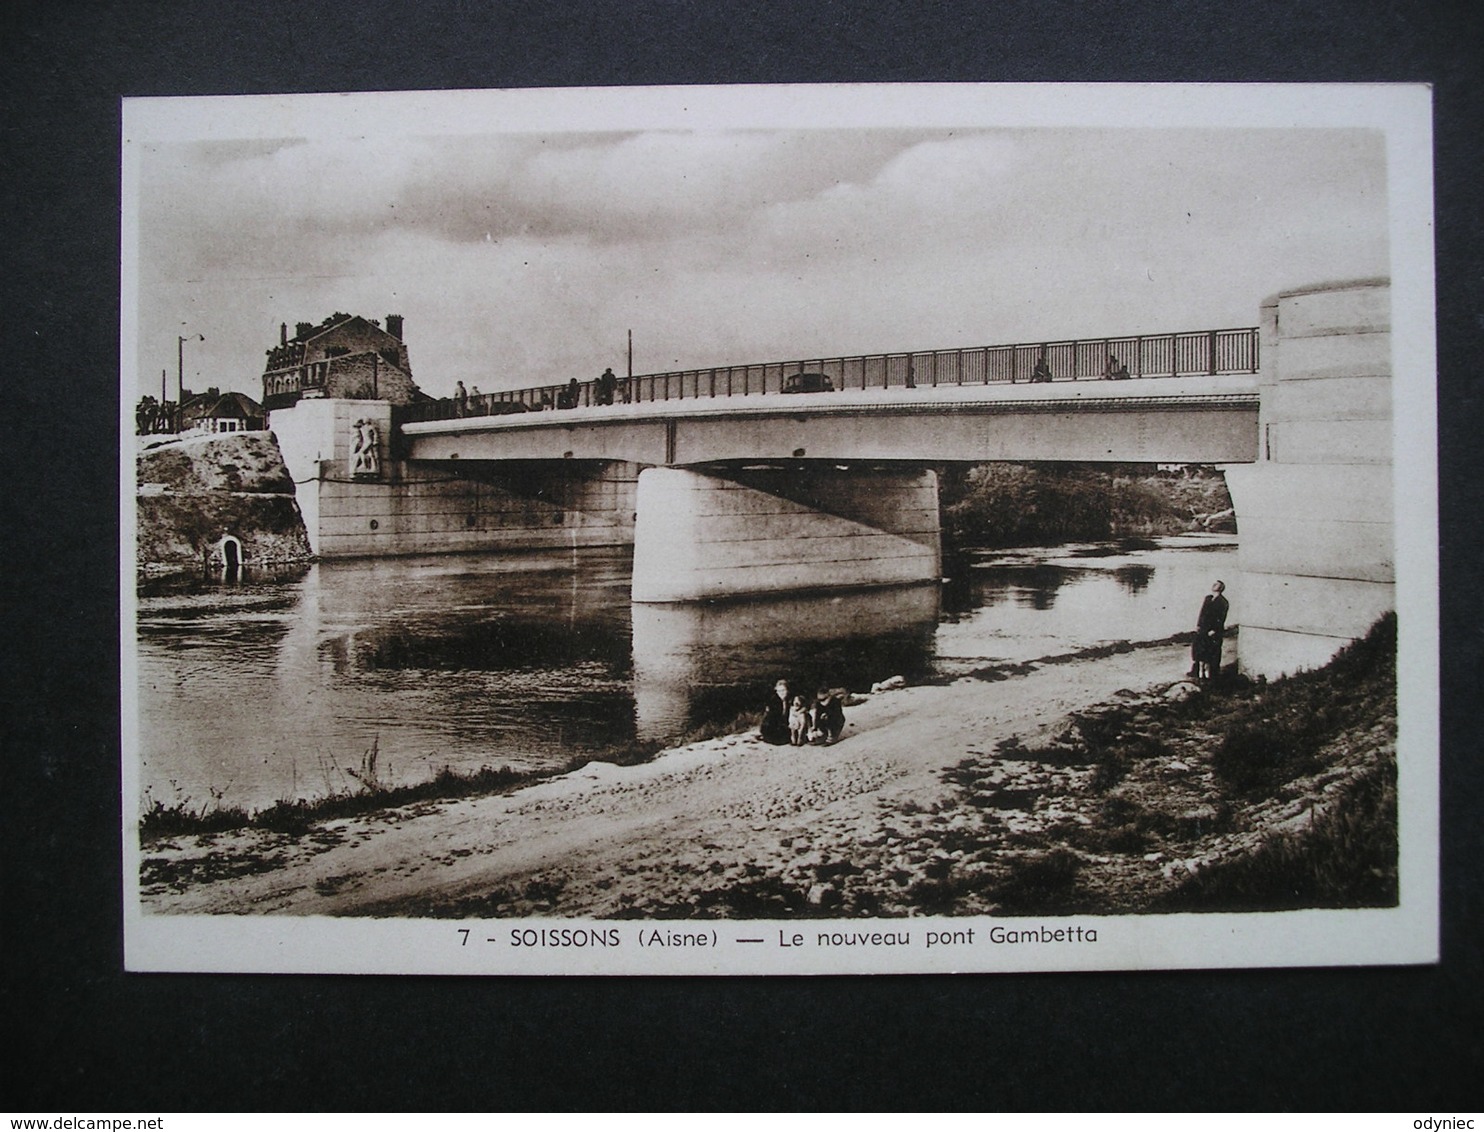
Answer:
270;280;1393;675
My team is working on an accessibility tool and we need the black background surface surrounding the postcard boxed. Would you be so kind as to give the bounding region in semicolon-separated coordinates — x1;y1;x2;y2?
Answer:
0;0;1484;1114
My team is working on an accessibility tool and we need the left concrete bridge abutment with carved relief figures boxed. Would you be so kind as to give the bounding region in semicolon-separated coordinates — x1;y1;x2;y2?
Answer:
270;398;638;558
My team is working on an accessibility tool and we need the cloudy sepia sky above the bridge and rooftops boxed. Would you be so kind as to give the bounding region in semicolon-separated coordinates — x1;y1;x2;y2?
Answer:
127;114;1389;406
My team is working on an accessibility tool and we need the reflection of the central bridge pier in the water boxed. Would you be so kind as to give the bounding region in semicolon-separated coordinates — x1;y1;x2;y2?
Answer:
632;586;938;739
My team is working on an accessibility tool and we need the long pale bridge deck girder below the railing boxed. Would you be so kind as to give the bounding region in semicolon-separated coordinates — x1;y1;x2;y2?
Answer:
402;375;1258;466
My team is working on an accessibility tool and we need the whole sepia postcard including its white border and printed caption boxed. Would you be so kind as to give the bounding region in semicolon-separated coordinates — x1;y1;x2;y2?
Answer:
119;85;1438;975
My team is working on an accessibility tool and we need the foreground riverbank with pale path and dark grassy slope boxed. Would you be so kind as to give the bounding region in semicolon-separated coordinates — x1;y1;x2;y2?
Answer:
141;620;1395;918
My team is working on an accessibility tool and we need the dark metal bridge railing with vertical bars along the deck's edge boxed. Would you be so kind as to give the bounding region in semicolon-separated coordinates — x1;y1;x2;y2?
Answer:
398;326;1258;421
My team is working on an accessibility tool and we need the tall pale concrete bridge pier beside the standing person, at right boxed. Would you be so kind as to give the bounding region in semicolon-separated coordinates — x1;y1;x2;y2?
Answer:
1224;279;1396;677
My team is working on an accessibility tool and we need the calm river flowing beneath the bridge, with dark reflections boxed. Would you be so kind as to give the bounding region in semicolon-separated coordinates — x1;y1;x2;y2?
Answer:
137;536;1236;810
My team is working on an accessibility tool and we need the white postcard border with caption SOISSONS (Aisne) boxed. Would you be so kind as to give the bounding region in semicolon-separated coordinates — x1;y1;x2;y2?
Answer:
119;85;1438;975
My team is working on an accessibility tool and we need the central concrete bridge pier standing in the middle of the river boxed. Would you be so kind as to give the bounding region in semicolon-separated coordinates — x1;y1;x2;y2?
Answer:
632;464;942;602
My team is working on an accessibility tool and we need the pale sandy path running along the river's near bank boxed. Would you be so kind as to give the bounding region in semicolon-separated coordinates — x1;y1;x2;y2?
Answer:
144;645;1187;918
